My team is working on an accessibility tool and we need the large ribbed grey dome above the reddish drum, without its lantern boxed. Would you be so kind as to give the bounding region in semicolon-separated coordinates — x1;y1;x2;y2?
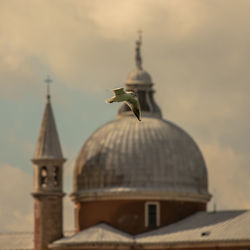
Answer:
74;116;209;201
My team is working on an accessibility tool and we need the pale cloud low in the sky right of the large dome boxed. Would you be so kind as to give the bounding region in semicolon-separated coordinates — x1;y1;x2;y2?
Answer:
201;144;250;210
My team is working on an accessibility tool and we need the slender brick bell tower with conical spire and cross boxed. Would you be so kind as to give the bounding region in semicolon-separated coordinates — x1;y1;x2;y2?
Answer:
32;77;65;250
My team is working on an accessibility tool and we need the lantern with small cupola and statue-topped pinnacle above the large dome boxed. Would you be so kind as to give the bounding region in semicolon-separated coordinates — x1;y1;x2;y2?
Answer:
118;31;162;118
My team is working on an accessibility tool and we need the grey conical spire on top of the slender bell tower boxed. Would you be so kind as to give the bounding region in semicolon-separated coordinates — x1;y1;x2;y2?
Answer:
34;80;63;159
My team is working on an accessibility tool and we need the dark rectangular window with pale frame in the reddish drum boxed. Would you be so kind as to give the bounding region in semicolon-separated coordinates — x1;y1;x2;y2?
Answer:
145;202;160;227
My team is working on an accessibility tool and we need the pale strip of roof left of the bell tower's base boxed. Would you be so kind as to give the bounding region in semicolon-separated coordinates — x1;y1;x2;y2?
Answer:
0;232;34;250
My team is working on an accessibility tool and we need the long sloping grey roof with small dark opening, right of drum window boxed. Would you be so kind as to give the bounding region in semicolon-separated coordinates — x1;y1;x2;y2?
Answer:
136;210;250;244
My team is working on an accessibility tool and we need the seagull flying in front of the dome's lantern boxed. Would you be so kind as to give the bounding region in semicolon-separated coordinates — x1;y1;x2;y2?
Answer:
106;88;141;121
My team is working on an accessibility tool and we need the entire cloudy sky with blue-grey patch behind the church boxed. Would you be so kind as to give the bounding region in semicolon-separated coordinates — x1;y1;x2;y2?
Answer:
0;0;250;231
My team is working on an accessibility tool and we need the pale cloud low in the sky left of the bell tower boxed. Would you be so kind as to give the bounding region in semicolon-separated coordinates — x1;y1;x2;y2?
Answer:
0;165;33;231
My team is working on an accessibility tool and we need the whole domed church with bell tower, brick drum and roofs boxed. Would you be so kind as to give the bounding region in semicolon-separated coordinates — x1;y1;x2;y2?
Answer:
0;36;250;250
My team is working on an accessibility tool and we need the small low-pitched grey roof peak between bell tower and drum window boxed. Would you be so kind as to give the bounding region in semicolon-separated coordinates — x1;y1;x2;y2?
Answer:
51;223;134;248
